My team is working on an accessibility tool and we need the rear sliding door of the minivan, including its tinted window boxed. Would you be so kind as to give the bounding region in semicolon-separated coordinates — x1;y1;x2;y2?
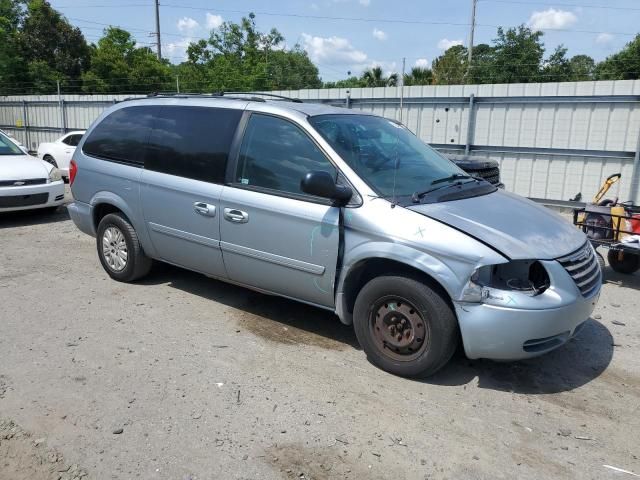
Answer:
140;105;242;278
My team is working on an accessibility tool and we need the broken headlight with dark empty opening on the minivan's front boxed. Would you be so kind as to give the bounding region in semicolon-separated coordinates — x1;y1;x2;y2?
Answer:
460;260;550;303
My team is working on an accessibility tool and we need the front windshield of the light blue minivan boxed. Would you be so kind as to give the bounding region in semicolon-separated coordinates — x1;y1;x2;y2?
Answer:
309;115;468;197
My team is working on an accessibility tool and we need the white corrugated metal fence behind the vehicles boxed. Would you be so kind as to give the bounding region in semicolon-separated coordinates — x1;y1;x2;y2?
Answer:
0;80;640;202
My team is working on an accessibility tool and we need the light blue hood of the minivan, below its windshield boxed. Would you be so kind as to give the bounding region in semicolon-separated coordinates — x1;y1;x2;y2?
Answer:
407;190;586;260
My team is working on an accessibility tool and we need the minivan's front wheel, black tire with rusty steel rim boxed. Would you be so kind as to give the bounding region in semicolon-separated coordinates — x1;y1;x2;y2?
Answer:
353;276;459;377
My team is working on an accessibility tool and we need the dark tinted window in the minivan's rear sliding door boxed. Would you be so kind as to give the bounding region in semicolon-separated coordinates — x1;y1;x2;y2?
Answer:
145;107;242;183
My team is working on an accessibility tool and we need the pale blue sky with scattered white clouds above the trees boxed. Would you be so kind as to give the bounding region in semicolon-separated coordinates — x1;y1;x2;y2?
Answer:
50;0;640;81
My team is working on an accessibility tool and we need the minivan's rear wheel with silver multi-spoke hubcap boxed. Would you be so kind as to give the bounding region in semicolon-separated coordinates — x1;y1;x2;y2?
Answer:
96;213;153;282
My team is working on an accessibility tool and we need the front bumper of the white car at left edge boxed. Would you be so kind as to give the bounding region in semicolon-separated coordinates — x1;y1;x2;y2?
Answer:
0;180;64;212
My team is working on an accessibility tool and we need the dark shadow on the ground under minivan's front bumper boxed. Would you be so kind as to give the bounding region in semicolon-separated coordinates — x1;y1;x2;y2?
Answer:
425;319;614;394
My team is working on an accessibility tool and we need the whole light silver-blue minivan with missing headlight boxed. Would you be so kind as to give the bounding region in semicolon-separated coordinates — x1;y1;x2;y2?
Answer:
69;95;602;376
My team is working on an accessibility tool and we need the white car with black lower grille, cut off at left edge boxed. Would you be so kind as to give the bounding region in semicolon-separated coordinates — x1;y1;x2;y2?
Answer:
0;133;64;212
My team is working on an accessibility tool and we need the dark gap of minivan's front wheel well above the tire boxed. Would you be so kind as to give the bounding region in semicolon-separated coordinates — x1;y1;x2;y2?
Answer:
343;258;453;313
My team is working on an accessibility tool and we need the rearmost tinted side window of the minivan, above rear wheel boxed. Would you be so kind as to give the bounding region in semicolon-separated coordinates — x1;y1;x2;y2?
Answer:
82;106;160;166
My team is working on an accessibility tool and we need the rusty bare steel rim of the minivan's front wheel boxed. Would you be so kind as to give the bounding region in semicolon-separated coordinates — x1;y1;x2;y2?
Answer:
369;297;429;361
